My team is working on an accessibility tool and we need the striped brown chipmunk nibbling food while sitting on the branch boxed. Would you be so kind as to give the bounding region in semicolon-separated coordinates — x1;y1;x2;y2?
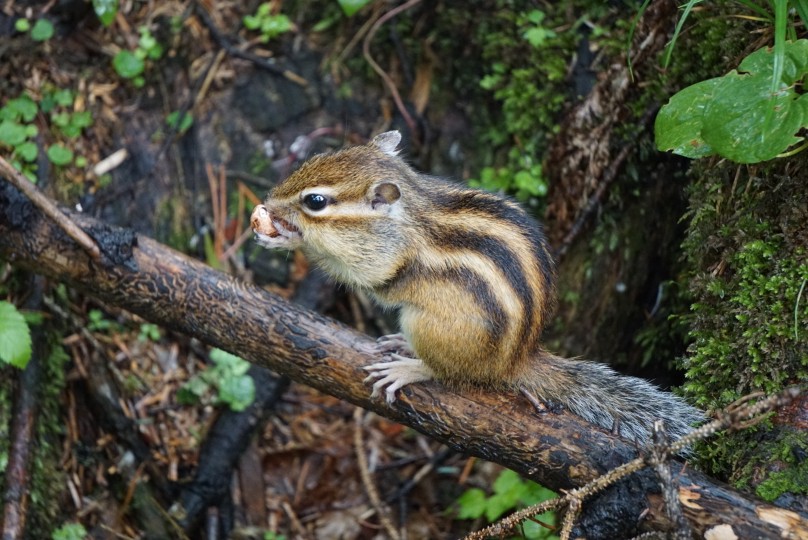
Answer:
251;131;703;445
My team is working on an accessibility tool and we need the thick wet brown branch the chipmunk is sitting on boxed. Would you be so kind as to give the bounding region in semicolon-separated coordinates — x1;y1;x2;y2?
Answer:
0;181;808;538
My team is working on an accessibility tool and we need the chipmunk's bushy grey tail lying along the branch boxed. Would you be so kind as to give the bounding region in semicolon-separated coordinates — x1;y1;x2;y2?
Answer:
516;352;705;446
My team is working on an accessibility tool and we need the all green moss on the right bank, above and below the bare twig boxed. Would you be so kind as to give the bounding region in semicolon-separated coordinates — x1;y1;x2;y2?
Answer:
683;156;808;486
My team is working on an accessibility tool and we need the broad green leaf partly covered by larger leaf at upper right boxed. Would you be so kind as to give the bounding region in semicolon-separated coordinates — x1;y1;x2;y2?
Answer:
654;77;723;159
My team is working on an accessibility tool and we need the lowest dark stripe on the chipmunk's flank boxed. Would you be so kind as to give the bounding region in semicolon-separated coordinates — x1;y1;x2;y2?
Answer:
375;262;508;343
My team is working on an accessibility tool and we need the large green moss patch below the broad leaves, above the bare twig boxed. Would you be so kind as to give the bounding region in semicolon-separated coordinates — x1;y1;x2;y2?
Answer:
685;167;808;408
